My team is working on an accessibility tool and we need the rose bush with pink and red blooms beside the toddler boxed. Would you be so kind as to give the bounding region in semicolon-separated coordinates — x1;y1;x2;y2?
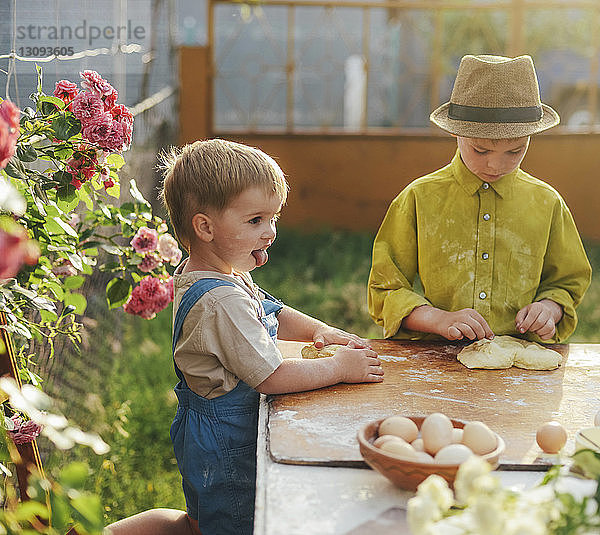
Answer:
0;68;181;533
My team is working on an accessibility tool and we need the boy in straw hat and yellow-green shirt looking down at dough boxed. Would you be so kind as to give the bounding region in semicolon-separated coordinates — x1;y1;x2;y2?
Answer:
368;55;591;342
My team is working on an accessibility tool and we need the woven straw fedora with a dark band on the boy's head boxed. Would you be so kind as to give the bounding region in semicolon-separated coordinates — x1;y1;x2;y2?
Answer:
429;55;560;139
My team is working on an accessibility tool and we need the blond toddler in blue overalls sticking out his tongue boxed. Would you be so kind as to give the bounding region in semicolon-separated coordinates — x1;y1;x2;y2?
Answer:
162;139;383;535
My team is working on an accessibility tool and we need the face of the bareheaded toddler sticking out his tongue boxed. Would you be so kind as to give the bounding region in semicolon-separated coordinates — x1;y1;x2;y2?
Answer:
211;186;281;273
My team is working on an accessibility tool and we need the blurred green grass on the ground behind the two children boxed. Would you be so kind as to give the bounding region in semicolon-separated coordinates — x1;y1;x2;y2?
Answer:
46;229;600;522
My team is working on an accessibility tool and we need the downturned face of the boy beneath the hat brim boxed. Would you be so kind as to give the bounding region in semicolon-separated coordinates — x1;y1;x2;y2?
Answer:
456;136;529;182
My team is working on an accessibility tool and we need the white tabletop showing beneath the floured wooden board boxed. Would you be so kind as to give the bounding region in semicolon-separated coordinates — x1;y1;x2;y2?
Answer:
254;396;544;535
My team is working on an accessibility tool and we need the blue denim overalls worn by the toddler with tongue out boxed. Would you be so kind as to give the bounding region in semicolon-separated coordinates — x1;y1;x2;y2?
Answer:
171;278;283;535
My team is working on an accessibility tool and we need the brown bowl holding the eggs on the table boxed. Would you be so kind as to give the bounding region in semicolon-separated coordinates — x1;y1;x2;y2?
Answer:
358;416;505;491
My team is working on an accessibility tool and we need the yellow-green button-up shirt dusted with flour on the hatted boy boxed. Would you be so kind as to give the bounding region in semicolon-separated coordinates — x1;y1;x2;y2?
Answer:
368;152;591;342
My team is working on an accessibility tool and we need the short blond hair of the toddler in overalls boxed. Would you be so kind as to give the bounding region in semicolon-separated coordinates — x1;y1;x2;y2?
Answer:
159;139;288;251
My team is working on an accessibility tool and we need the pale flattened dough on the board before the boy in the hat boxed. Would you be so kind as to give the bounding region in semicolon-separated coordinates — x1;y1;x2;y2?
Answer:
457;336;562;370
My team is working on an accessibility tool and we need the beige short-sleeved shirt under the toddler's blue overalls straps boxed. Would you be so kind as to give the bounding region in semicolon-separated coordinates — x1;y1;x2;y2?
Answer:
173;263;283;399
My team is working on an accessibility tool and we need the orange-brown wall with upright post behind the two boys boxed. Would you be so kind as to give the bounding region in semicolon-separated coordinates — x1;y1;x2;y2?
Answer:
179;48;600;241
